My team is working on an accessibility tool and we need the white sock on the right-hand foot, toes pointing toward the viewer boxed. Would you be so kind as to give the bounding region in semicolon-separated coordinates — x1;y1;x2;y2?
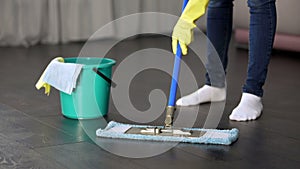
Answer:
229;93;263;121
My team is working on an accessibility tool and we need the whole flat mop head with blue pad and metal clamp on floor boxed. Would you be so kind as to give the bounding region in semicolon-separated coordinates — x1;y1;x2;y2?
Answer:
96;121;239;145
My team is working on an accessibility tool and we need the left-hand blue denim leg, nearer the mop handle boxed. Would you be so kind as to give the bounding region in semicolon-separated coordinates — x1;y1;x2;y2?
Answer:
205;0;233;87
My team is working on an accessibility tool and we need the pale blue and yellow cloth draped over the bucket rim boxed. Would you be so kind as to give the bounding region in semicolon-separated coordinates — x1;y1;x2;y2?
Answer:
35;57;83;95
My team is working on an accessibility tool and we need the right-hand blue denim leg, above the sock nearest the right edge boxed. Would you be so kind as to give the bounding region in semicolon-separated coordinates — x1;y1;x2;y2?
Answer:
243;0;276;97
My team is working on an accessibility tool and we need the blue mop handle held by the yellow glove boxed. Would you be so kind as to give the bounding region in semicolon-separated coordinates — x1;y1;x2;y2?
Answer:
168;0;189;107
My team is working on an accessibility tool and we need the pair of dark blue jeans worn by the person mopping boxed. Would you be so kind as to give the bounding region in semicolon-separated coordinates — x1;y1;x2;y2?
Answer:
206;0;277;97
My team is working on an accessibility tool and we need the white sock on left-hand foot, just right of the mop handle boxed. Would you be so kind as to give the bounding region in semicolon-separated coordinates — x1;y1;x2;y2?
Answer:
176;85;226;106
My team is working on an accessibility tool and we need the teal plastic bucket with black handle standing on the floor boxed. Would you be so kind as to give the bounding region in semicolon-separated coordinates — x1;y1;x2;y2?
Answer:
60;57;116;119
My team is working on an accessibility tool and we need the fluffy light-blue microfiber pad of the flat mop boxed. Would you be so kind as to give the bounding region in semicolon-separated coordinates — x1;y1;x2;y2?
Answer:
96;121;239;145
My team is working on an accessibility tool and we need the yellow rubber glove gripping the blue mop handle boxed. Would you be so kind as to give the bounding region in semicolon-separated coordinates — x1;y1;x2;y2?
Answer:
172;0;209;55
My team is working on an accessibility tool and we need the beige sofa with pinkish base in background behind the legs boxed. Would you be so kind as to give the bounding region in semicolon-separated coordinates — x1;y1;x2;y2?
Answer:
234;0;300;52
